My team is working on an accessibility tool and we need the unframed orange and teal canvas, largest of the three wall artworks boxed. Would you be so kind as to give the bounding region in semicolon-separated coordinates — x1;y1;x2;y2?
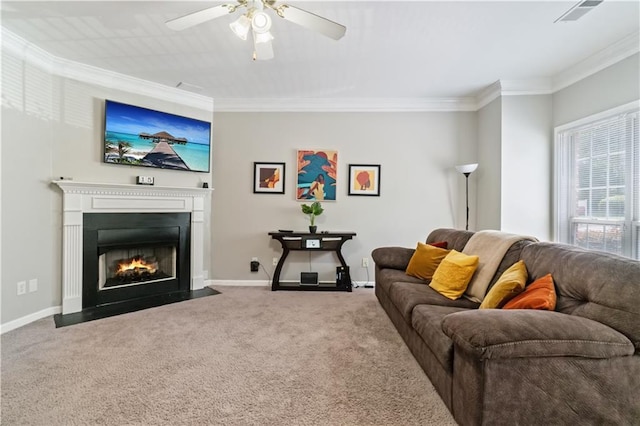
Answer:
296;149;338;201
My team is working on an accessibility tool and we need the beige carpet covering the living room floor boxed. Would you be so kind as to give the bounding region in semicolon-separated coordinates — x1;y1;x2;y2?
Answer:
1;286;455;425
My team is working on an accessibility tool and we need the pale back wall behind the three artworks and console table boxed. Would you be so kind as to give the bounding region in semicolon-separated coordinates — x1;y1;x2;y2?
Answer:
211;112;476;281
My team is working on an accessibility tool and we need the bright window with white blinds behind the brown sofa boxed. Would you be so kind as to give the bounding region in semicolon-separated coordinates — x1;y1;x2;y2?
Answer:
555;102;640;259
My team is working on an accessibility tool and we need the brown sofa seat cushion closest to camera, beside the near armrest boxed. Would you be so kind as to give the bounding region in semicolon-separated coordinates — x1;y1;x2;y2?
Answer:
411;305;466;372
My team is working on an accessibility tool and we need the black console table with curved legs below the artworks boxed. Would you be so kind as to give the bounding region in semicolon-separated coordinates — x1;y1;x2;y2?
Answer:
269;232;356;291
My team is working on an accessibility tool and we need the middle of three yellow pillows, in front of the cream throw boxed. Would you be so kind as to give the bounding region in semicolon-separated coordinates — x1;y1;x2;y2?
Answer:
429;250;479;300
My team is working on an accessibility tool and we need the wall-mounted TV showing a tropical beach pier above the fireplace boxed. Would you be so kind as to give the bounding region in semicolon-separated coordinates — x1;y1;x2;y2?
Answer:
104;100;211;172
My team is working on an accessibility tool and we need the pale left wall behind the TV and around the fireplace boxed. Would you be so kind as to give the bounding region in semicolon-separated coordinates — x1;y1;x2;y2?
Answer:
0;46;212;324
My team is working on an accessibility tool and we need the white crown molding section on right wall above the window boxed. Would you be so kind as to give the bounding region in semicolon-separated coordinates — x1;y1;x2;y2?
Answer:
551;31;640;92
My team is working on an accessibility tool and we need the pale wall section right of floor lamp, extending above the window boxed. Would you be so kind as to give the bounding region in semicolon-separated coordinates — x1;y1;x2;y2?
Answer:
470;50;640;240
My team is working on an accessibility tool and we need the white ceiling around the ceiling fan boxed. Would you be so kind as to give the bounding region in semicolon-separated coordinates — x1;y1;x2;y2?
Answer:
0;0;640;110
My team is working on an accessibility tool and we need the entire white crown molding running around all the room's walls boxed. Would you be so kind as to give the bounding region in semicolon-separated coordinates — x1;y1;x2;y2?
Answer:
2;27;640;112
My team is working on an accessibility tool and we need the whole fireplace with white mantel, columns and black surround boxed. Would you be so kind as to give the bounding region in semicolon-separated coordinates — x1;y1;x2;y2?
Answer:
53;180;212;315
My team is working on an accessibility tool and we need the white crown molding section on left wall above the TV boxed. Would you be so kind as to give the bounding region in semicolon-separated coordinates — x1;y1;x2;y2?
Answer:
2;27;214;112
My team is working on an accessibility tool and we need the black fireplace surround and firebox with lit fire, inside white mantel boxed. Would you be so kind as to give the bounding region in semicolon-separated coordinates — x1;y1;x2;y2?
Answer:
82;213;191;309
